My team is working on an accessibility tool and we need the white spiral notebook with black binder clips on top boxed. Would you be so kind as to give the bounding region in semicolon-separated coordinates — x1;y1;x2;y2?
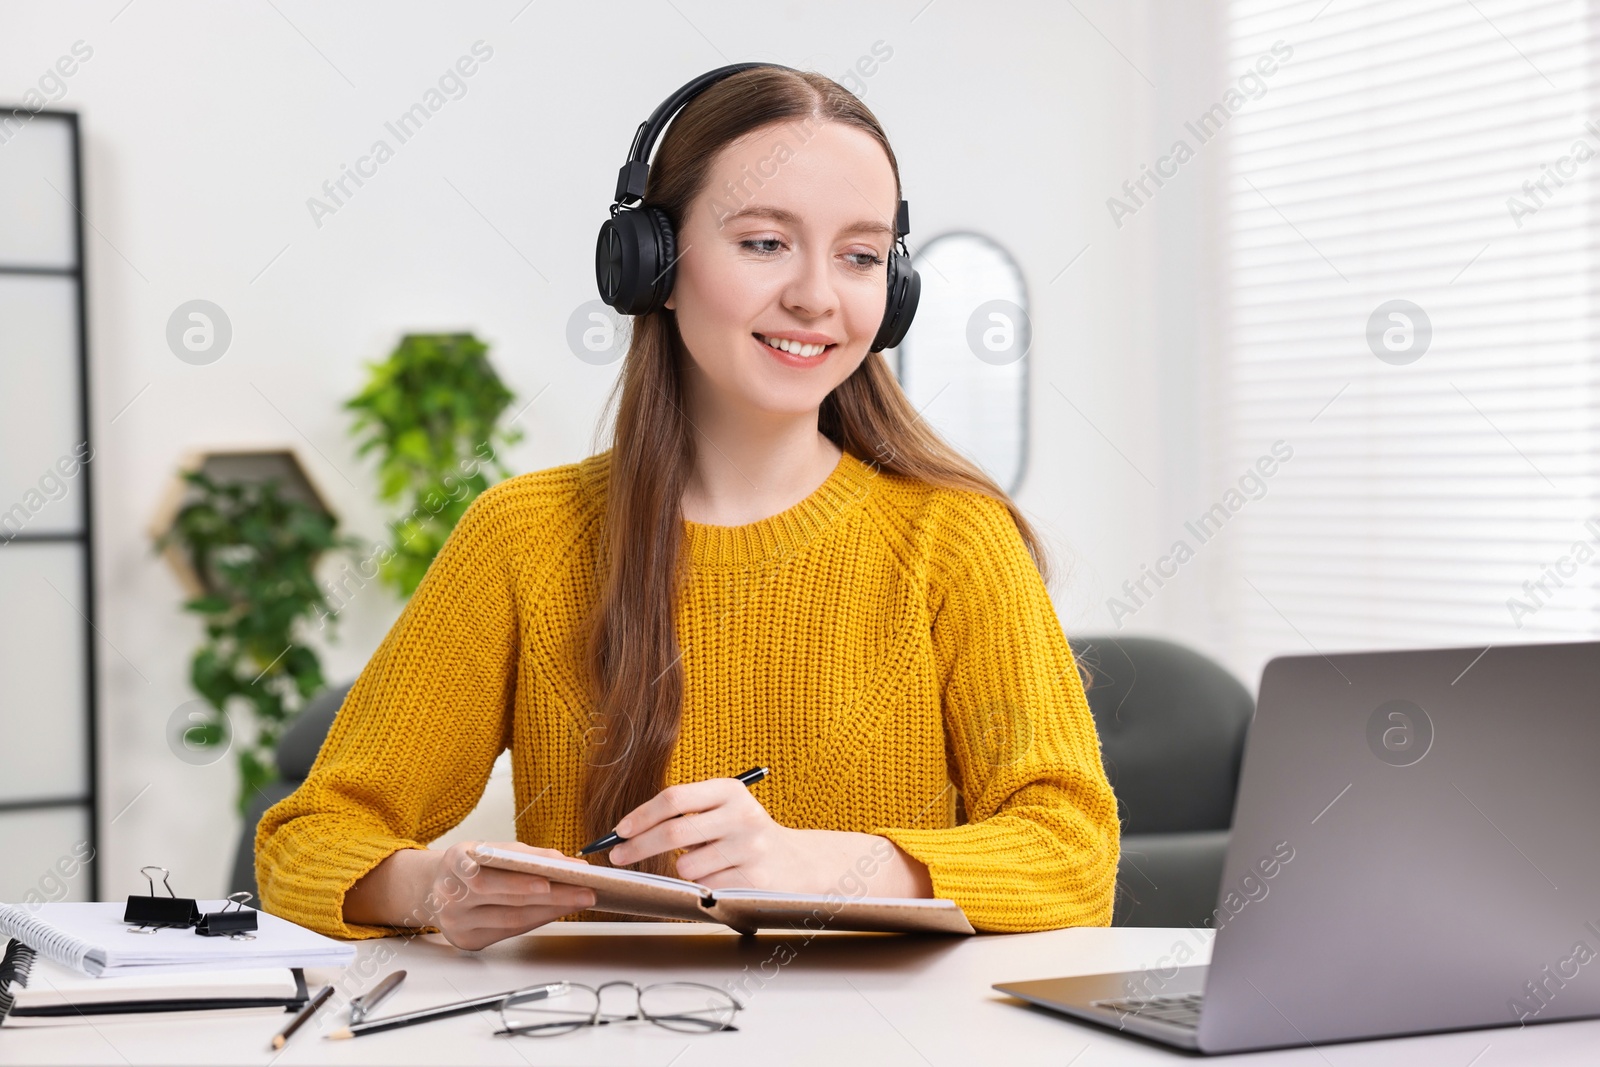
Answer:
0;901;355;977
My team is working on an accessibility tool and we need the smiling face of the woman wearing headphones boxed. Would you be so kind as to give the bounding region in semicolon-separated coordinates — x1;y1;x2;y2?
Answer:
667;120;898;414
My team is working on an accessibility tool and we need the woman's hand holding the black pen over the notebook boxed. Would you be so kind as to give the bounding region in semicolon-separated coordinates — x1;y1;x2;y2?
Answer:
611;777;933;897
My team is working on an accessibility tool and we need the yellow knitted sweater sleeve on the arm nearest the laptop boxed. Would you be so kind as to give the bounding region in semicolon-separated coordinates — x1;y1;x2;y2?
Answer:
874;494;1120;931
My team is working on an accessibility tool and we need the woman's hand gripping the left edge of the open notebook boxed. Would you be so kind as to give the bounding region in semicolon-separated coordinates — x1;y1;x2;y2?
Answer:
410;841;595;949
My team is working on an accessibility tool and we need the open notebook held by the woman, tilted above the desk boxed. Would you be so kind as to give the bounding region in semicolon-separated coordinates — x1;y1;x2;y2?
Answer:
472;845;976;934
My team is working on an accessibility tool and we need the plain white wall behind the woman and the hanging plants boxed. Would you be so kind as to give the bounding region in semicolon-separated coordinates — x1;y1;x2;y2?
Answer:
0;0;1203;899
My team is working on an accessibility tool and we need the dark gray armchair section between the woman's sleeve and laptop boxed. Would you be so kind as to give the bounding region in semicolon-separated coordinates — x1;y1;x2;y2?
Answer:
1070;637;1256;926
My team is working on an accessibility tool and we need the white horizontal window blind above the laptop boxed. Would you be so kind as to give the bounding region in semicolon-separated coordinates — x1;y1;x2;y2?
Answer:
1213;0;1600;684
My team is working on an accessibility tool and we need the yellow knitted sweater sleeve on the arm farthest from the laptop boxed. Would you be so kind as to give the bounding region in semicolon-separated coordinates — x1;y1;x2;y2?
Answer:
256;483;517;937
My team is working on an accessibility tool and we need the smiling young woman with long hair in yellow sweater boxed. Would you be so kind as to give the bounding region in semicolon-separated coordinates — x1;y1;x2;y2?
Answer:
256;67;1118;949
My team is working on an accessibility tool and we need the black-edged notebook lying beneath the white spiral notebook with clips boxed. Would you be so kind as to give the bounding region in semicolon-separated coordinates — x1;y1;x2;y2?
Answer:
0;939;307;1029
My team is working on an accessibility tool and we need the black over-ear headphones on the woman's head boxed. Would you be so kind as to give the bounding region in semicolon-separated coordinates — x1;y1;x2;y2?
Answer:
595;62;922;352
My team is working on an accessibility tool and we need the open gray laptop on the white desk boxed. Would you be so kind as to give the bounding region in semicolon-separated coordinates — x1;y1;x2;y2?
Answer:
994;641;1600;1053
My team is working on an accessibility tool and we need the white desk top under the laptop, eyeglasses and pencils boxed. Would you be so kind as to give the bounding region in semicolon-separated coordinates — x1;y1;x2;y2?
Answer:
12;923;1600;1067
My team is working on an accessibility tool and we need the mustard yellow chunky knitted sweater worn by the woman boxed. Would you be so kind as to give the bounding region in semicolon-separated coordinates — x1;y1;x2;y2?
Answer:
256;451;1120;937
